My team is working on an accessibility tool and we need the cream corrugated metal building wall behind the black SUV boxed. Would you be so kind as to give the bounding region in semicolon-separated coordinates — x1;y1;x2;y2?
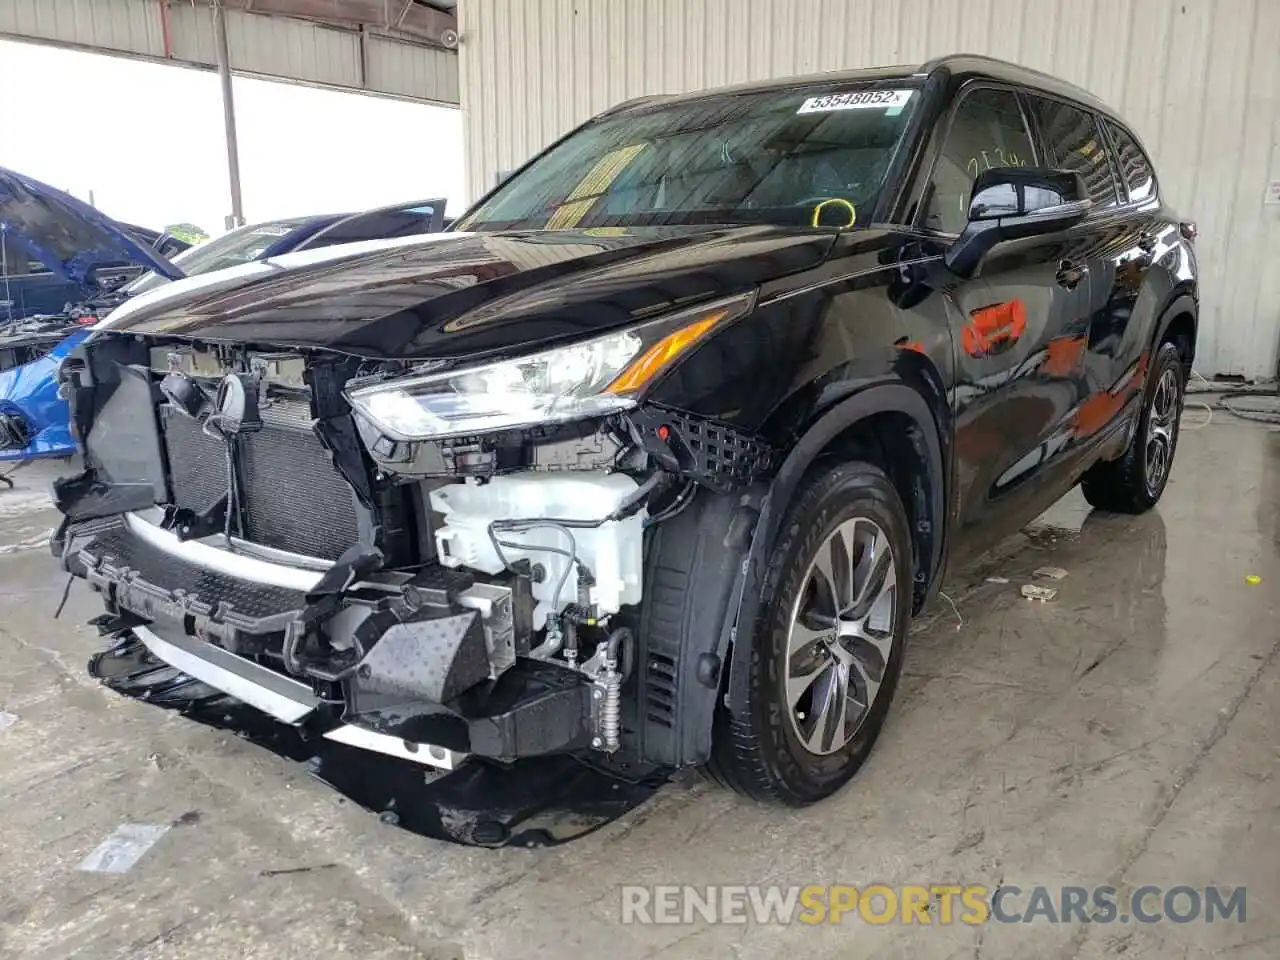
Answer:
458;0;1280;376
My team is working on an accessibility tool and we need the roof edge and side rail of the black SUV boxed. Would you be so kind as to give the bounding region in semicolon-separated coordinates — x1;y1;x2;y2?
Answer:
605;54;1116;116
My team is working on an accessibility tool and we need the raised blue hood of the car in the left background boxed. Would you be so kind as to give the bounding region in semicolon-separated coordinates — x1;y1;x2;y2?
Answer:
0;166;183;293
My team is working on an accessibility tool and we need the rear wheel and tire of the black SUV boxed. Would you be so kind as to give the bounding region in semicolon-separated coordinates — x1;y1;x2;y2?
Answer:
1080;343;1187;513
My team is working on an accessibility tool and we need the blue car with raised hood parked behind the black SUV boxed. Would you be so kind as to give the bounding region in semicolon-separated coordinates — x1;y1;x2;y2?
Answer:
0;168;448;462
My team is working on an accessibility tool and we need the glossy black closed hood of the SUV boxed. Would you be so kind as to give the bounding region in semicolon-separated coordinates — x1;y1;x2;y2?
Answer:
99;227;836;360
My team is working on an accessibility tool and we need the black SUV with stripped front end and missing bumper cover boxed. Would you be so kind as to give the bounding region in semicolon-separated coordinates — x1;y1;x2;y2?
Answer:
54;56;1198;804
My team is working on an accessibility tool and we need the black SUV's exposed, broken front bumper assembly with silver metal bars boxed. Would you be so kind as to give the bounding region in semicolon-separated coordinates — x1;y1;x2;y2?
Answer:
54;511;593;771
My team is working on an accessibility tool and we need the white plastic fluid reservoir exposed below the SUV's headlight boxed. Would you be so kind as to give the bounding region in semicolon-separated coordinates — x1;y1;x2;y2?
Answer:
430;471;645;630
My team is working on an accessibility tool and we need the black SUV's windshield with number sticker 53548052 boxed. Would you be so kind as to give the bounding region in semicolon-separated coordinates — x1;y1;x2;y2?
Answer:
454;81;919;230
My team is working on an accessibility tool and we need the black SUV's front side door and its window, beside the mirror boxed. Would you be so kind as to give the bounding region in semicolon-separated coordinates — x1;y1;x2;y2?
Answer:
919;84;1088;556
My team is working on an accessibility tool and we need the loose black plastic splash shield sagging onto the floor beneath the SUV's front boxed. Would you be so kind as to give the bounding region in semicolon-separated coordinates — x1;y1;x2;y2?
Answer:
88;634;667;847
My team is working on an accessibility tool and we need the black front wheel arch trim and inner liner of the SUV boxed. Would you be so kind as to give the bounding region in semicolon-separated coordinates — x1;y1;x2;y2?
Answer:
636;381;948;764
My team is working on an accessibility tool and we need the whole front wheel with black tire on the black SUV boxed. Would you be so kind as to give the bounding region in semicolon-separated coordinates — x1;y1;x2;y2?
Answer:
707;462;913;806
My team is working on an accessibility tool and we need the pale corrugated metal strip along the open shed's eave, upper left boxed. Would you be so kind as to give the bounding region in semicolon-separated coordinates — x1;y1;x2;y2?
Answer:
0;0;458;105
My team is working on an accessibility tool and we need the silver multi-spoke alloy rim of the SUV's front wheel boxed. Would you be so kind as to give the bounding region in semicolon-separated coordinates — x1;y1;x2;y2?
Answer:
783;517;899;754
